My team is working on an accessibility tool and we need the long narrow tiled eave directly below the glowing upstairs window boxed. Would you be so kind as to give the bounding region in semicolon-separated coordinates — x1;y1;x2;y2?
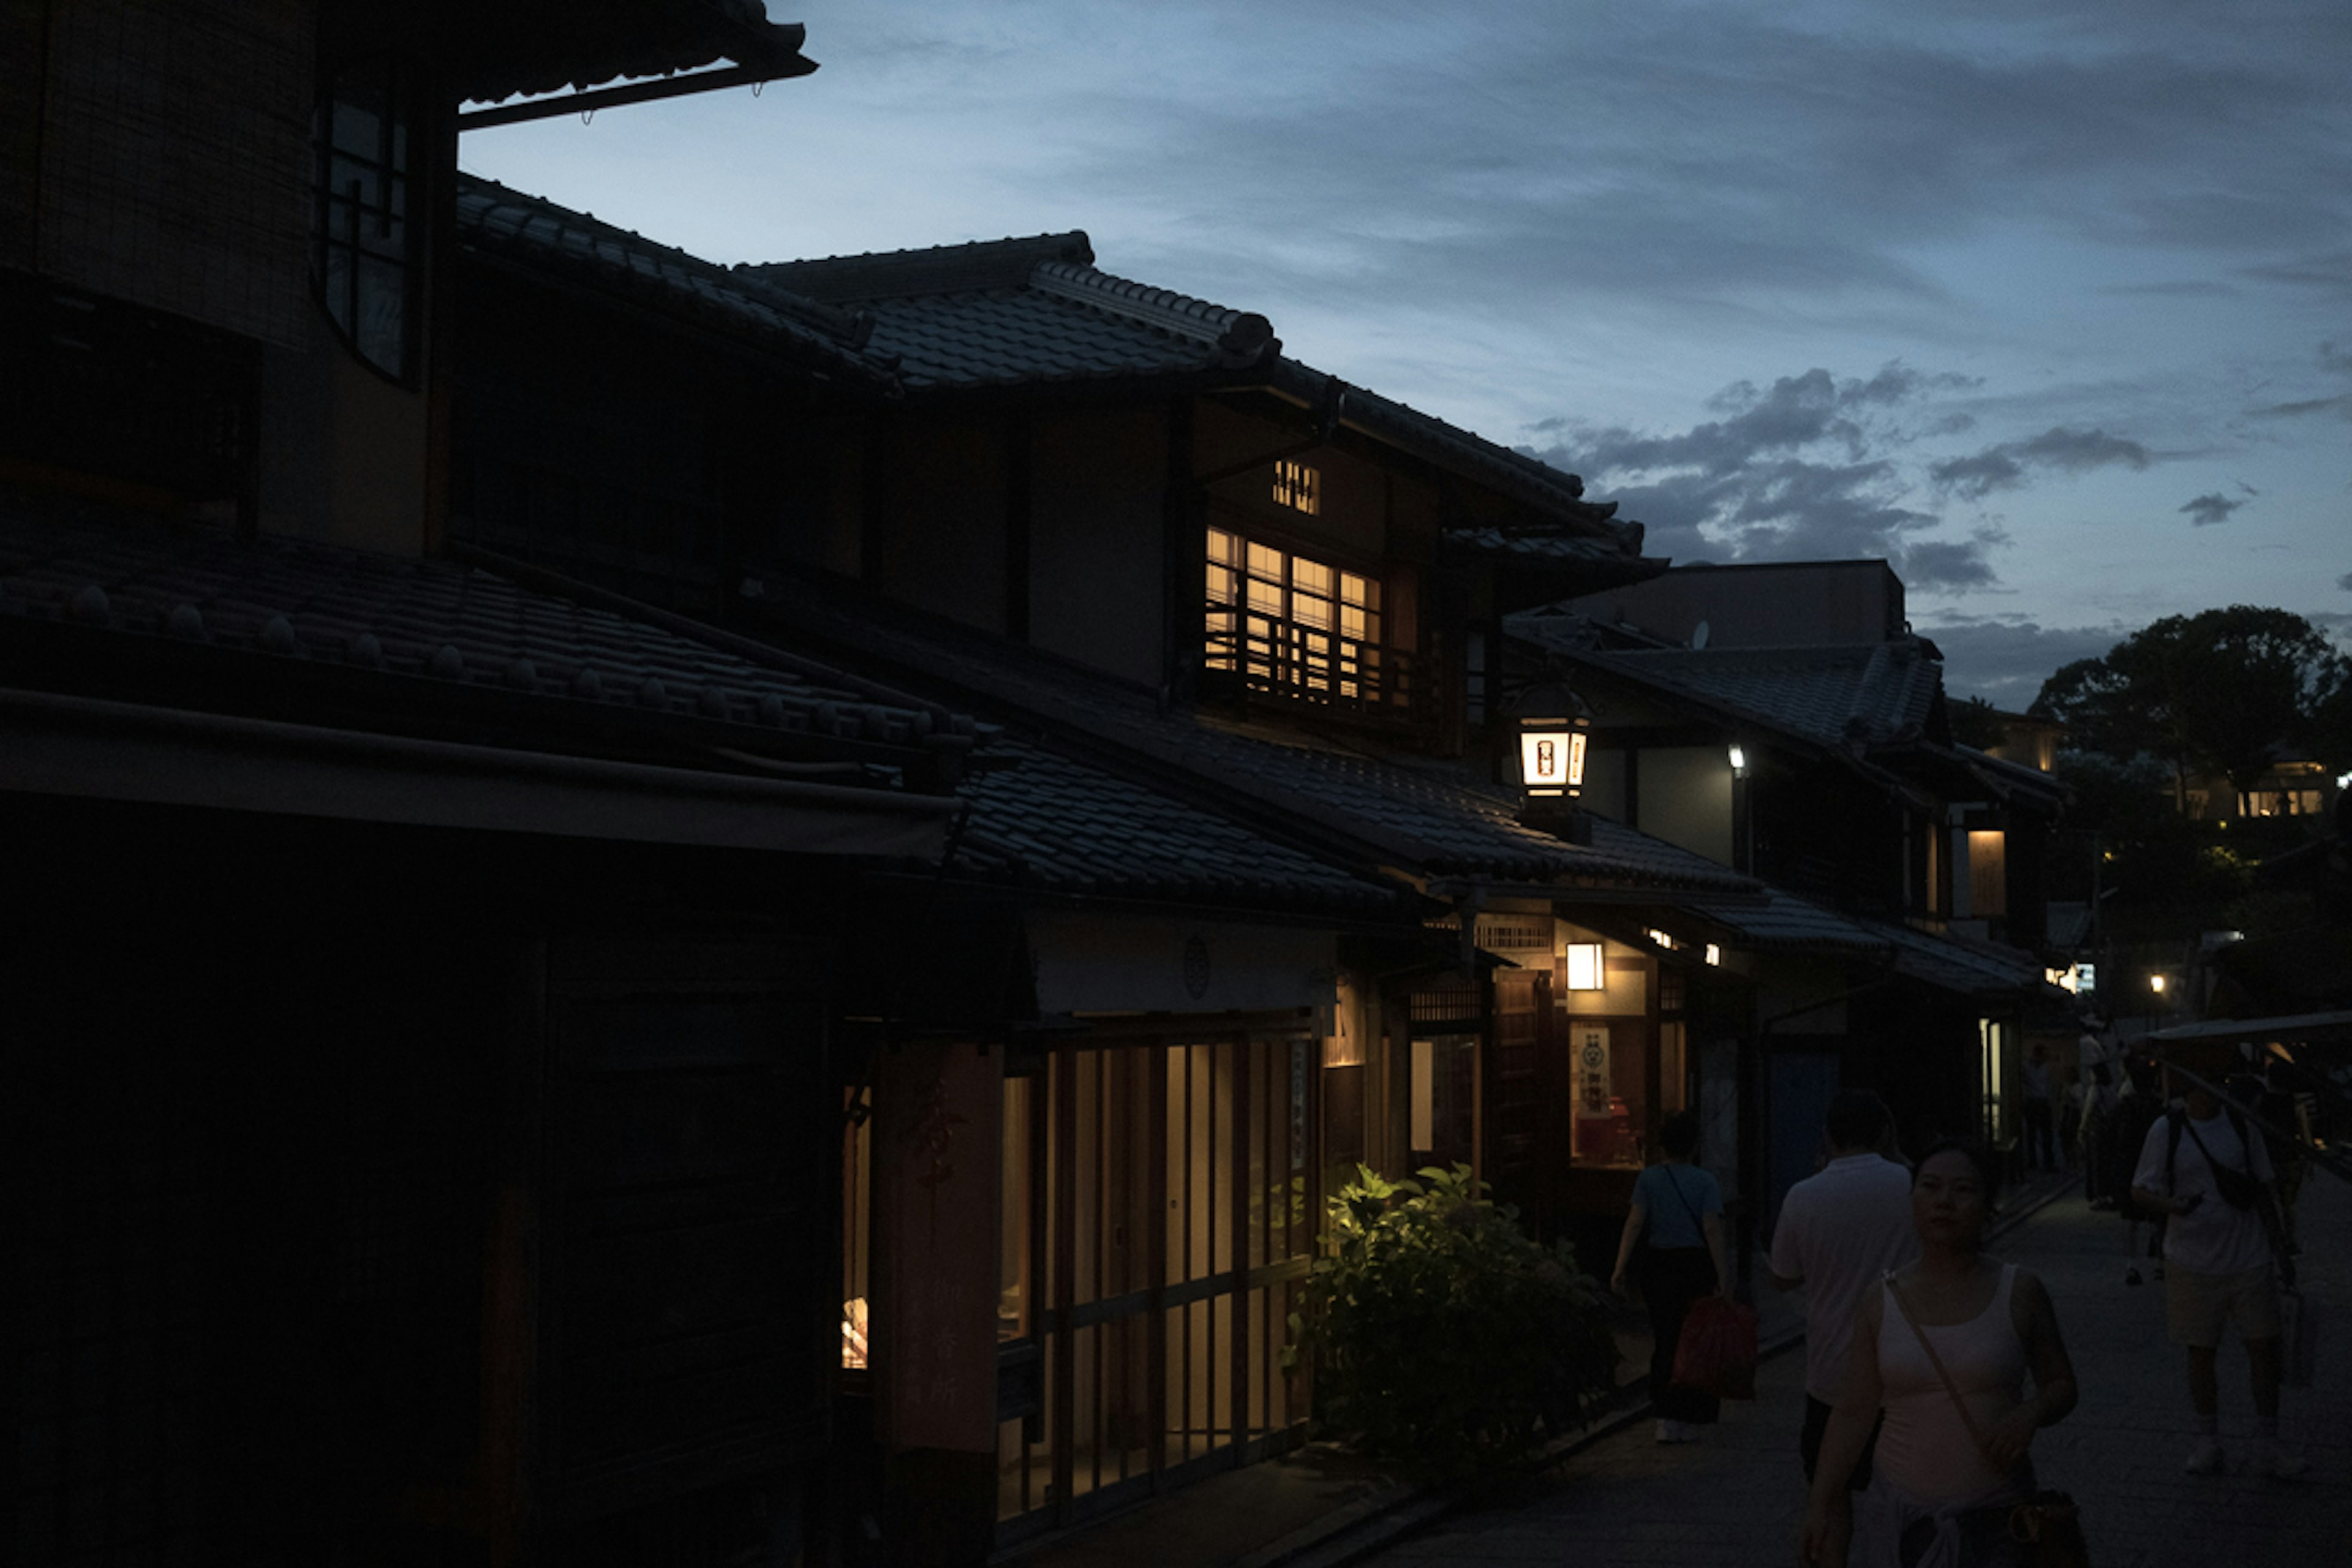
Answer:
755;578;1755;895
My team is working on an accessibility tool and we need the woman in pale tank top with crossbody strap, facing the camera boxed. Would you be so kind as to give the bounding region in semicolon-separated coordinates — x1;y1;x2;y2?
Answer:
1800;1140;2075;1568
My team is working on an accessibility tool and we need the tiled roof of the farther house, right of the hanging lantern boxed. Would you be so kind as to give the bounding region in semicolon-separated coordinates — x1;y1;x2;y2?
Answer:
1507;614;1943;748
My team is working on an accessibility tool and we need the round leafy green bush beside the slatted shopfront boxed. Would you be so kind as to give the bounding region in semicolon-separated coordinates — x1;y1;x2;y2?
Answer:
1284;1164;1618;1481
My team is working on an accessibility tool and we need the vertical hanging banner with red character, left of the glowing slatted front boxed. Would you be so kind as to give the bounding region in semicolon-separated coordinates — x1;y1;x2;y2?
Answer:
870;1041;1005;1453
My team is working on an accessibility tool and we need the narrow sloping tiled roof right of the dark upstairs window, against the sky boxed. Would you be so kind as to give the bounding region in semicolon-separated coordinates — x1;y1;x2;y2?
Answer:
456;174;891;388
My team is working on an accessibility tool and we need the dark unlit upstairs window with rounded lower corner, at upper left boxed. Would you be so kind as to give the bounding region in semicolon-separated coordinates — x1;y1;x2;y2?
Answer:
315;61;421;381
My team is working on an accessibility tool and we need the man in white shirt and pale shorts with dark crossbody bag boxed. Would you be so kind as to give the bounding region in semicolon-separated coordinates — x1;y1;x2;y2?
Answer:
2131;1088;2302;1481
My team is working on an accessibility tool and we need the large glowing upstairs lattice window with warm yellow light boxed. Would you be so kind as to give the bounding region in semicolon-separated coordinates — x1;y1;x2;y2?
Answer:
1204;529;1392;703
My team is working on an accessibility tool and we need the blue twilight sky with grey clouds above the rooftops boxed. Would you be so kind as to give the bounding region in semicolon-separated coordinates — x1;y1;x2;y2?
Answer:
461;0;2352;705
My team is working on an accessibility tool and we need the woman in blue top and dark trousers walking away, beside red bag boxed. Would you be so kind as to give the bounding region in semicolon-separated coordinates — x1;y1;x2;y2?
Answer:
1609;1110;1731;1444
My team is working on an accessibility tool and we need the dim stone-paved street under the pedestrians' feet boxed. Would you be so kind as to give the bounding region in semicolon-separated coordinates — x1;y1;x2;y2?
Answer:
1374;1173;2352;1568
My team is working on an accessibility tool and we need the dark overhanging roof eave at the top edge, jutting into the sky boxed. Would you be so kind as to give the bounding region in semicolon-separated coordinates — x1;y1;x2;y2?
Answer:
456;0;816;101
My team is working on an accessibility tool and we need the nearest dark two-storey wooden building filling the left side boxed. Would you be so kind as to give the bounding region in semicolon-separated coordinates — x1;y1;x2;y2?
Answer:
0;0;992;1563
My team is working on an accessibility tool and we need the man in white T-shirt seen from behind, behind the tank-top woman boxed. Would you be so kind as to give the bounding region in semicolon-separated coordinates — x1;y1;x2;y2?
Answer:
1771;1088;1919;1568
